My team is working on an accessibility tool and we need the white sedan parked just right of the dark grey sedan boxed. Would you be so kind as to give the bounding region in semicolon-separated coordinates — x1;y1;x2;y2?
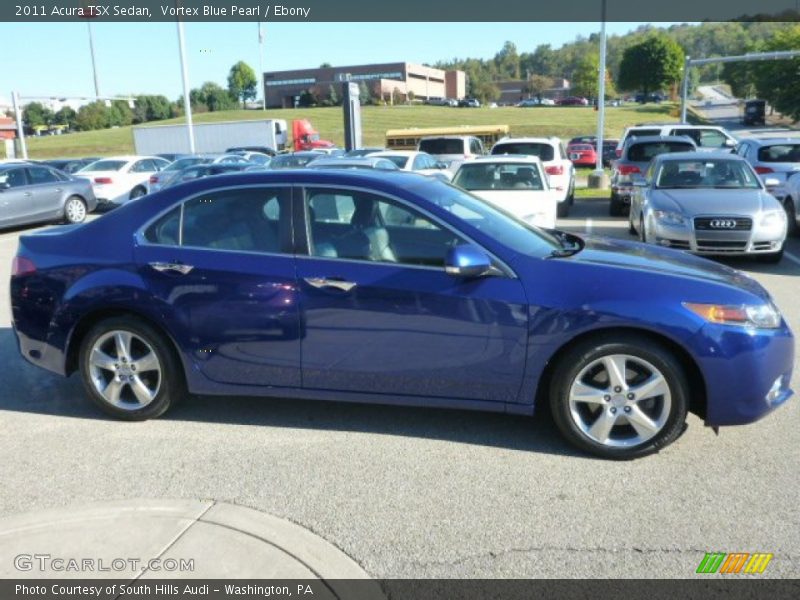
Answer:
75;156;170;207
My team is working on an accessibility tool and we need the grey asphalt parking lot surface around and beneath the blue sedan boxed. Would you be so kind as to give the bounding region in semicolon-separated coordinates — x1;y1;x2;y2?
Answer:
0;201;800;578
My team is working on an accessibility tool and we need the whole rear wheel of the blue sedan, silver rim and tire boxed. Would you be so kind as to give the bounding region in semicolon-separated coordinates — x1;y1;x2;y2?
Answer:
79;317;185;421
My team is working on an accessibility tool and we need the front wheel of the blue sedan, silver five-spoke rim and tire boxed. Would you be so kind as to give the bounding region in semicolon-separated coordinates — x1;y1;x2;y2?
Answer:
550;336;689;459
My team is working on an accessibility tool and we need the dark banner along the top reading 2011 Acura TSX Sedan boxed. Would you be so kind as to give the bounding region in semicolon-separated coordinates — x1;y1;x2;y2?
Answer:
0;0;798;23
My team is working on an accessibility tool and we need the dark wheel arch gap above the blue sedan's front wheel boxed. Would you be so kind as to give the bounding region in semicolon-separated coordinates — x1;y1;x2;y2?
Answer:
535;327;708;420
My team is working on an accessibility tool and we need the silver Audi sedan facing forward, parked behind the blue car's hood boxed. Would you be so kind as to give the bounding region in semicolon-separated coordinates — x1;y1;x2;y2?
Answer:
629;152;786;262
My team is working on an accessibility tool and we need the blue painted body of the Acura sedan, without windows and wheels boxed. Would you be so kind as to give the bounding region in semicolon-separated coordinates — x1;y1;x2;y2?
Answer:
11;170;794;426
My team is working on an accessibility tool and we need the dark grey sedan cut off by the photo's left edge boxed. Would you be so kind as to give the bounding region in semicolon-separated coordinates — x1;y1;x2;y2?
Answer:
0;163;97;228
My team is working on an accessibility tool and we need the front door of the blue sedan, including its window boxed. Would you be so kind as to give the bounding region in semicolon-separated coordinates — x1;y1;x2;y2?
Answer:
295;187;528;402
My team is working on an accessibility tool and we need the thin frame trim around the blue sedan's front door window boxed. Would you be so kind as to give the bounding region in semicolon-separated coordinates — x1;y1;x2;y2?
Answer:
292;183;519;279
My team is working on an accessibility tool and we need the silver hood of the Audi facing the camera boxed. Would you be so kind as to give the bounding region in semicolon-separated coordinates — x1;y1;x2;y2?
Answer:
651;188;779;217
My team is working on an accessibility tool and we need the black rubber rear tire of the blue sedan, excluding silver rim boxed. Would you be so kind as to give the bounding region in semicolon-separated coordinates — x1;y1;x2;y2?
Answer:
78;316;186;421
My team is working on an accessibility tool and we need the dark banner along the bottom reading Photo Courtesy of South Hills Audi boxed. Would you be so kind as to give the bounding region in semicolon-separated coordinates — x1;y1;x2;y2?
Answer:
0;575;800;600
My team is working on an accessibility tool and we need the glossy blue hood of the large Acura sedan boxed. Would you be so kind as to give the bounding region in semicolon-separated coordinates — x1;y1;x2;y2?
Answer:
557;236;769;300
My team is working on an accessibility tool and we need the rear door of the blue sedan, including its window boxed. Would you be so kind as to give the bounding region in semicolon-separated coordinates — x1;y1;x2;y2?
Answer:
135;186;301;393
